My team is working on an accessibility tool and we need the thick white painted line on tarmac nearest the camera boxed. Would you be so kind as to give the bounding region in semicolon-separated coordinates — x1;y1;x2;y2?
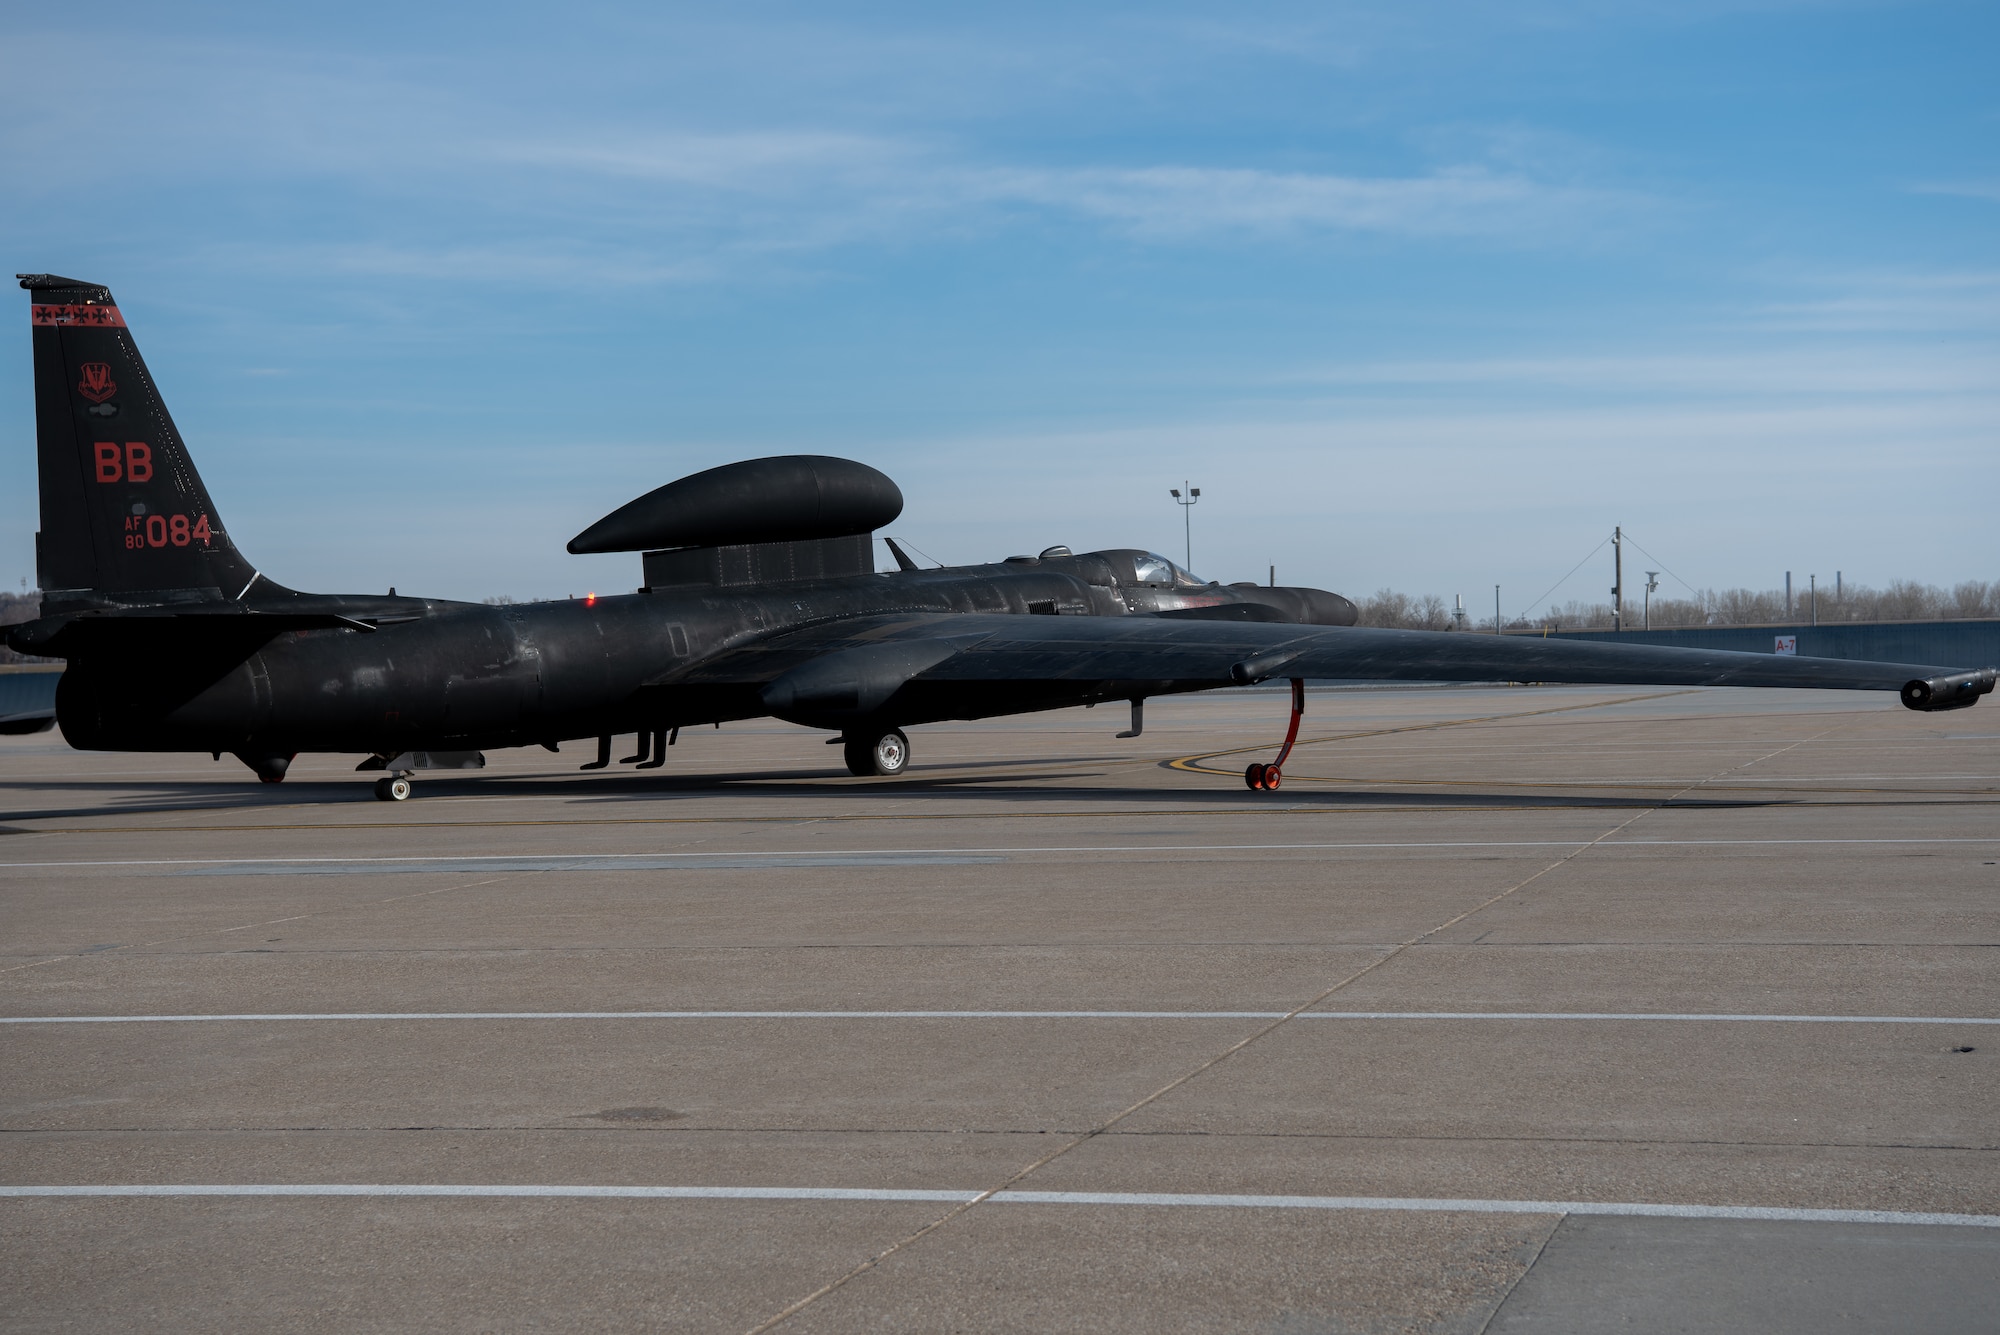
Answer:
0;1183;2000;1229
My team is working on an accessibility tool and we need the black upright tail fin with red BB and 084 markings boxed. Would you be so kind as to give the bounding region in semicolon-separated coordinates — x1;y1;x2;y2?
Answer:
16;274;258;604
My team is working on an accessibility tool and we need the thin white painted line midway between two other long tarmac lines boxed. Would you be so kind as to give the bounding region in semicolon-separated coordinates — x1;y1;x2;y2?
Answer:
0;1011;2000;1025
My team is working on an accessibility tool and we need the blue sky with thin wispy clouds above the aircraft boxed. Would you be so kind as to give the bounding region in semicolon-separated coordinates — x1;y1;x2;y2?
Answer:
0;0;2000;616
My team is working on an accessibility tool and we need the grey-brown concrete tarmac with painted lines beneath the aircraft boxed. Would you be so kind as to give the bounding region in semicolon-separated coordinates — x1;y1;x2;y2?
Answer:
0;687;2000;1335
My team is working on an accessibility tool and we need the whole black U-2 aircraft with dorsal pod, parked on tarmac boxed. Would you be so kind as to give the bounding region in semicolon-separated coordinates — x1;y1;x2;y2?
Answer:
8;274;1996;799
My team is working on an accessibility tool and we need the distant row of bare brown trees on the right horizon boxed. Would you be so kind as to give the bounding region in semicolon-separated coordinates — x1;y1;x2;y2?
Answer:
1360;580;2000;634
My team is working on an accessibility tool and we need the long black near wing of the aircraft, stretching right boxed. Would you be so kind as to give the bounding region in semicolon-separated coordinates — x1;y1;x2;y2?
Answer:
676;614;1996;721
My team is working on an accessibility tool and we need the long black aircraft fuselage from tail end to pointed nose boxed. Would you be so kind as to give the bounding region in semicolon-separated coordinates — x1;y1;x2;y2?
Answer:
56;554;1354;755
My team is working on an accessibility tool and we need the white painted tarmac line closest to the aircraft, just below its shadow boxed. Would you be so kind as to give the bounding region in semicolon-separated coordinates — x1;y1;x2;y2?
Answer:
0;835;2000;871
